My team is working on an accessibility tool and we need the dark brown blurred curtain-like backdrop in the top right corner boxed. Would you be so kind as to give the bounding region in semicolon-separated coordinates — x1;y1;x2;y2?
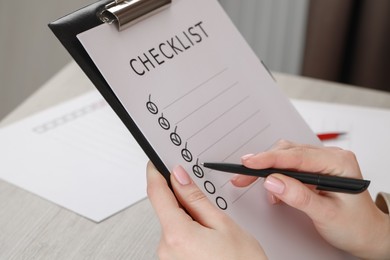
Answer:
302;0;390;92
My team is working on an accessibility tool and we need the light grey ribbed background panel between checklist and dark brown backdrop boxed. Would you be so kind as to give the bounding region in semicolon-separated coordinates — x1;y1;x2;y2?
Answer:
219;0;309;74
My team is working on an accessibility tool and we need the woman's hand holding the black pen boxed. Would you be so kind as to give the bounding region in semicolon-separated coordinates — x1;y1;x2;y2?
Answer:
232;141;390;259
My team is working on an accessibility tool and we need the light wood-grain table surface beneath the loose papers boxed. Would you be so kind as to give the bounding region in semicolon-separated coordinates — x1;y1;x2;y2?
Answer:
0;62;390;259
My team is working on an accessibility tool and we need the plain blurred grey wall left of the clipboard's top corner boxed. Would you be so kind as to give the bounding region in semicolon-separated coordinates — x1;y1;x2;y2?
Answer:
0;0;94;119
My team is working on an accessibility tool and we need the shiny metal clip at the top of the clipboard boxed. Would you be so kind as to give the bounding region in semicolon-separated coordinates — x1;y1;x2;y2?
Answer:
98;0;172;31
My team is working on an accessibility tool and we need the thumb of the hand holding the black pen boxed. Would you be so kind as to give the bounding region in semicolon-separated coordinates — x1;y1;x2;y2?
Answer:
264;174;331;221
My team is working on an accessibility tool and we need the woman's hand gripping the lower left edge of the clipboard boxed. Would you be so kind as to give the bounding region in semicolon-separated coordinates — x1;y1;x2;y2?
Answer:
147;162;266;260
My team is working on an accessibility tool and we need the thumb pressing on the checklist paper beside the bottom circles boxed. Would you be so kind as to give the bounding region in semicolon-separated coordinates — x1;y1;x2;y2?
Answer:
171;166;224;228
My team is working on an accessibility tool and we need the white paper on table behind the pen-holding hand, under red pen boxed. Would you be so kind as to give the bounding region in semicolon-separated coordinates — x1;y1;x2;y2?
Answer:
293;100;390;198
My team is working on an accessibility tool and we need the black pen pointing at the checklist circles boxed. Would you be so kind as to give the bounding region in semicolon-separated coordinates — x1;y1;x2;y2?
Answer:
203;162;370;194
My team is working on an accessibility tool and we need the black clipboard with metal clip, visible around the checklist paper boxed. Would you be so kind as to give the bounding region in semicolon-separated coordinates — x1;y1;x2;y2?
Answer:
48;0;171;183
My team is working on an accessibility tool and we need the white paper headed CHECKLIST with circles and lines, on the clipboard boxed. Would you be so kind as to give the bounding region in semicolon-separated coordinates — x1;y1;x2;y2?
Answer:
78;0;352;259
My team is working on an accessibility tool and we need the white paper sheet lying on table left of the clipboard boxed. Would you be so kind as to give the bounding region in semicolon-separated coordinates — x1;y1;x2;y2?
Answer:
0;91;147;222
